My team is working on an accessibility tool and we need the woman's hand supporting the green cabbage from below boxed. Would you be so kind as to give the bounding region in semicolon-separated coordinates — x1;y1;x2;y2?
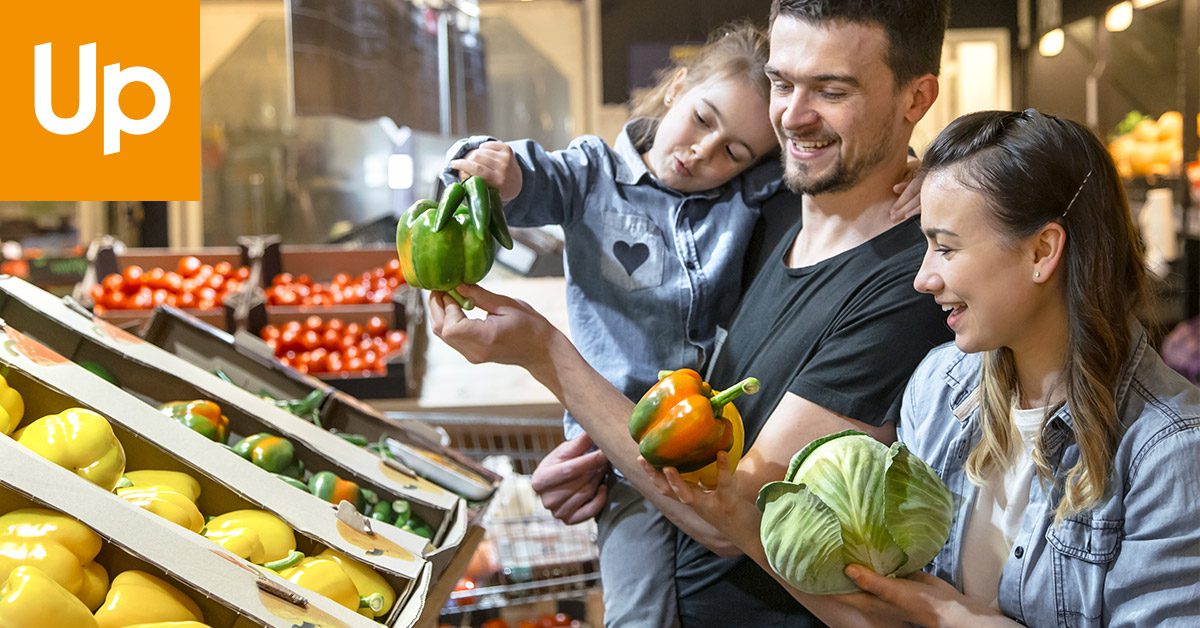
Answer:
846;564;1018;628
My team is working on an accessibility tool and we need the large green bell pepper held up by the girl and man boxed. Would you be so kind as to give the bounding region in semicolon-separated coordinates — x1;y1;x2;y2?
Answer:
396;177;512;310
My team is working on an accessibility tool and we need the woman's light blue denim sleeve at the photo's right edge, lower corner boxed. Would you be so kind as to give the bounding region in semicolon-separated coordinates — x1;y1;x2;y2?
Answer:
1104;417;1200;628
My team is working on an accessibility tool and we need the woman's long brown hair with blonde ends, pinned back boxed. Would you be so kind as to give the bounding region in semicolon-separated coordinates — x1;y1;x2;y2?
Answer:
924;109;1146;524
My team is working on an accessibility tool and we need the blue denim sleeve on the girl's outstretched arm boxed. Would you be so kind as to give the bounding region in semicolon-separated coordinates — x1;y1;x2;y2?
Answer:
504;139;597;227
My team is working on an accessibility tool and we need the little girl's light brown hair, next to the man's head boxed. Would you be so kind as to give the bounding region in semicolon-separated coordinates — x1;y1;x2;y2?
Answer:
630;20;770;145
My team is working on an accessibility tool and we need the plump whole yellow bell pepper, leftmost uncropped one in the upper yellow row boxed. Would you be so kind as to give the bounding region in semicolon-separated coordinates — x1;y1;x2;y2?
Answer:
18;408;125;491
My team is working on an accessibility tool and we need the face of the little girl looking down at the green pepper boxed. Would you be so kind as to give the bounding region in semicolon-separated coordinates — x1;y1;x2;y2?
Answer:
642;78;778;193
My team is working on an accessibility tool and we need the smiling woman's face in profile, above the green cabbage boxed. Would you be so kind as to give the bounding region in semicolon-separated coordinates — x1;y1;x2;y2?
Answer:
913;168;1046;353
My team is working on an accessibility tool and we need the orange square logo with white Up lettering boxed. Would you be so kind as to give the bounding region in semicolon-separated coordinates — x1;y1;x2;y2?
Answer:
0;0;200;201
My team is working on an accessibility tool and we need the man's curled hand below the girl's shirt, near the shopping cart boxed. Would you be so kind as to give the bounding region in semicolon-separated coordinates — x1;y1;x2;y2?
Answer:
532;433;608;525
